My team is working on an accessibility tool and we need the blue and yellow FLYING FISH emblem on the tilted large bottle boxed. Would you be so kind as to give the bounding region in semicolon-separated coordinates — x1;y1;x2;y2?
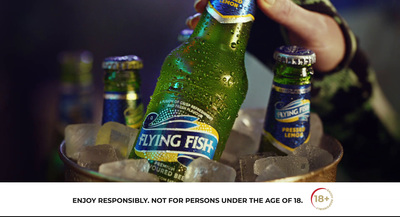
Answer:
135;103;219;167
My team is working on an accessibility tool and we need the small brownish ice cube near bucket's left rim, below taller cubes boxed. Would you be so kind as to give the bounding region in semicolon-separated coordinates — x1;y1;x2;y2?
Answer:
77;144;122;171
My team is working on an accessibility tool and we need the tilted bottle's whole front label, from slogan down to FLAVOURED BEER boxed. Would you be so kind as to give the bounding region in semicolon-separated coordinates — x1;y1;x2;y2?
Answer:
134;99;219;181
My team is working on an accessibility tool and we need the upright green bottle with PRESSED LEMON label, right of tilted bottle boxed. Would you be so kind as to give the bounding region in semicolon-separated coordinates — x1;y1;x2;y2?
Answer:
259;46;316;155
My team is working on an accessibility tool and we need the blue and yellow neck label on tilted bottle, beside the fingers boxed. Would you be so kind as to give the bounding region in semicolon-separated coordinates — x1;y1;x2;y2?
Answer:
206;0;255;23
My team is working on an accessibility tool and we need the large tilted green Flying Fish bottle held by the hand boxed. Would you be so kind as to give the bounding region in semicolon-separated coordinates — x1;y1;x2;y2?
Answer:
130;0;255;181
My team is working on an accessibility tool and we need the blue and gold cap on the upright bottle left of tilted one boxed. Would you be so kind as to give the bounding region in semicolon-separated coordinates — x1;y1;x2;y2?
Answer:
102;55;143;70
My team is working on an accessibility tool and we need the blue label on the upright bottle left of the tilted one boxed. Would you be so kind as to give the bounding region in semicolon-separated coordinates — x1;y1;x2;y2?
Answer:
102;91;144;128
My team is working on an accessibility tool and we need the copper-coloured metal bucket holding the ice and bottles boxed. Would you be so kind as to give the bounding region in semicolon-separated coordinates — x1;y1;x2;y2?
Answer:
59;135;343;182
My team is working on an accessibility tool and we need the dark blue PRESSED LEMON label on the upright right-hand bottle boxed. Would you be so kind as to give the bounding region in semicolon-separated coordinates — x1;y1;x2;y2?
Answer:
264;82;311;154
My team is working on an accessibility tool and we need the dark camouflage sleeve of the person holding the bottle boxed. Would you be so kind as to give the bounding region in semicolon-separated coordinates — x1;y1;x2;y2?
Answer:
296;0;400;180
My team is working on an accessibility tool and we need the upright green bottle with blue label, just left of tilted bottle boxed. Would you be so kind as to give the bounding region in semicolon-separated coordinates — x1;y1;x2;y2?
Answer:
102;55;144;128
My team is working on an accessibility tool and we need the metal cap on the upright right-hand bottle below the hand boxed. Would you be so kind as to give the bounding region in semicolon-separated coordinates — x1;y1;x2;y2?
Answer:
274;46;316;66
